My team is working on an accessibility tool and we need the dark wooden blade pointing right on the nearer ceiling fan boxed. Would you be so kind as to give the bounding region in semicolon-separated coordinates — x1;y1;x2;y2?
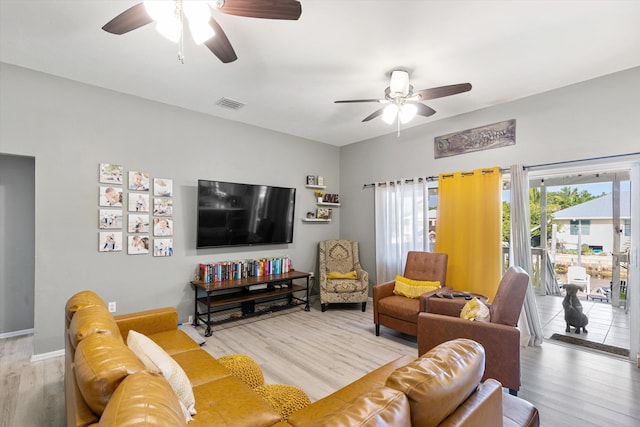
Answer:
216;0;302;21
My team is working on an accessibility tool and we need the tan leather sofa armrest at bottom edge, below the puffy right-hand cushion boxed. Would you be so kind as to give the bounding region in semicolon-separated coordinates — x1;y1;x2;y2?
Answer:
439;379;503;427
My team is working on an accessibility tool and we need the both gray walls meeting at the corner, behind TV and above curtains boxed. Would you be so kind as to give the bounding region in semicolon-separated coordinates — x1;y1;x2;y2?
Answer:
0;64;640;354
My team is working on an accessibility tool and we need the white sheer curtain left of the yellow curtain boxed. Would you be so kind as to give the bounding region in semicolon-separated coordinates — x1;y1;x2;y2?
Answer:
375;178;429;283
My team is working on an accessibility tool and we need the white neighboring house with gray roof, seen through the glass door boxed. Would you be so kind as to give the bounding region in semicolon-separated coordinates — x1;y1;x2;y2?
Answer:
553;190;631;253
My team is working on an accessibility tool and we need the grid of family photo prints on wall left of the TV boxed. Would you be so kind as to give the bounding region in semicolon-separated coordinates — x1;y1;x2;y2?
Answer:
98;163;173;257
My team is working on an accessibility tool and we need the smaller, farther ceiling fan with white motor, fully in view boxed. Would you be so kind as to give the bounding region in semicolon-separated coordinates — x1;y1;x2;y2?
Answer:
335;70;471;135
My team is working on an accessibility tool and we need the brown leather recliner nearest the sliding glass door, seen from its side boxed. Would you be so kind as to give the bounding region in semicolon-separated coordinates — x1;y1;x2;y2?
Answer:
418;266;529;395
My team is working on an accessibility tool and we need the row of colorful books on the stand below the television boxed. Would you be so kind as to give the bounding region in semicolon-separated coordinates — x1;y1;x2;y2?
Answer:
199;257;291;283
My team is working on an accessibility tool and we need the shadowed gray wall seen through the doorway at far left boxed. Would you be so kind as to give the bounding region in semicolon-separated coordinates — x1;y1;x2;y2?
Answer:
0;154;35;335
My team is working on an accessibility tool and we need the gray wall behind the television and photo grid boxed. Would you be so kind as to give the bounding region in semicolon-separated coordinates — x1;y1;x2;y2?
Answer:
0;64;340;354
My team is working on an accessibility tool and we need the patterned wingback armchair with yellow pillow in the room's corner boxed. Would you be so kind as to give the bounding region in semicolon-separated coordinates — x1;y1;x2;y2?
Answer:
318;240;369;311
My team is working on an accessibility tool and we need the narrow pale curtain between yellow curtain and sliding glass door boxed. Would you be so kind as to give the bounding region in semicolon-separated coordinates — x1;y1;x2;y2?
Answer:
509;164;544;347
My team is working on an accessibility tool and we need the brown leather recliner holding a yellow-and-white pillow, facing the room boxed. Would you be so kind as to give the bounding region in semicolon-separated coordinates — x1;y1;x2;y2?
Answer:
373;251;449;336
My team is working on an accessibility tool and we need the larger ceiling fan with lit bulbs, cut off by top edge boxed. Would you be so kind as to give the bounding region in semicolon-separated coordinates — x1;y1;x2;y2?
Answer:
102;0;302;63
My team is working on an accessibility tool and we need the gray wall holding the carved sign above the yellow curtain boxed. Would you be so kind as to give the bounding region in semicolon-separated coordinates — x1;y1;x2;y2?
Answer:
340;68;640;283
